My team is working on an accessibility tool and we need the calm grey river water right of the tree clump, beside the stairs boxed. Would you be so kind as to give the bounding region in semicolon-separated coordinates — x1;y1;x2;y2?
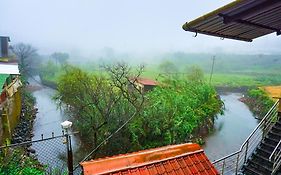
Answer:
203;93;258;161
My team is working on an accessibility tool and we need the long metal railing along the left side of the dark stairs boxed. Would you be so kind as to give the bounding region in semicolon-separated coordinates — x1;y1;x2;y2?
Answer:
212;101;279;175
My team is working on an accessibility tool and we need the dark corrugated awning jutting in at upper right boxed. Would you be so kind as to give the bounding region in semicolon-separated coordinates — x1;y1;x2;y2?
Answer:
183;0;281;42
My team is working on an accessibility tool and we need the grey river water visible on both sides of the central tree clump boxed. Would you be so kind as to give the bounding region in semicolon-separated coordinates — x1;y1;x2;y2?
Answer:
31;81;258;161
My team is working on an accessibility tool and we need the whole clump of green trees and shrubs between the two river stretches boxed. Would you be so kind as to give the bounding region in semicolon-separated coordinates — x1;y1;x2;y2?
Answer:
52;63;222;156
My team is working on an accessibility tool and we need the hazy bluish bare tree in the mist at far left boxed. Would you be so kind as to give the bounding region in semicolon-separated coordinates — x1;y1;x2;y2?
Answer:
11;43;39;74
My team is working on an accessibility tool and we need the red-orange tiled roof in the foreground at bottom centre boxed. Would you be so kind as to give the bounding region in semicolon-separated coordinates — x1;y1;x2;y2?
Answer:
81;143;219;175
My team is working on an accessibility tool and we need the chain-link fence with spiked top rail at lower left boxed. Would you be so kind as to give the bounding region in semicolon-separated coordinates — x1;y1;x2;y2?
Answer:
0;134;82;175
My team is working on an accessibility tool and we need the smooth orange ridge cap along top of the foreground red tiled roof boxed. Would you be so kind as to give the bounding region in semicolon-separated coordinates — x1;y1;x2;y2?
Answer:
80;143;203;174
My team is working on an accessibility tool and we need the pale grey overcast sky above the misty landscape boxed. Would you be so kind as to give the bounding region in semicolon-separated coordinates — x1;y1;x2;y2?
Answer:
0;0;281;54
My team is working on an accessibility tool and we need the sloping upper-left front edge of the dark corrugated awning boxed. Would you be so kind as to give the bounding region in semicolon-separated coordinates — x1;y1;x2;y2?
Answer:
182;0;244;31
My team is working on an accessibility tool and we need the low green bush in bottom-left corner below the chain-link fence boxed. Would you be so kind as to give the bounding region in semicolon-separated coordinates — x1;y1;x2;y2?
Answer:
0;148;44;175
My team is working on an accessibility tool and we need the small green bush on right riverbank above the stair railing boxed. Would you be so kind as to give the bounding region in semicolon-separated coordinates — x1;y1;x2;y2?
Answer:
246;89;274;118
